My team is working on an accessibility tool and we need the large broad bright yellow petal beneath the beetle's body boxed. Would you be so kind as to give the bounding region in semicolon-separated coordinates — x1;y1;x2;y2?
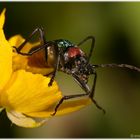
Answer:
1;70;62;114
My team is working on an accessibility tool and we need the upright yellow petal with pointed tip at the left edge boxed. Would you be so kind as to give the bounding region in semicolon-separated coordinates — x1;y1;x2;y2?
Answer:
0;10;12;90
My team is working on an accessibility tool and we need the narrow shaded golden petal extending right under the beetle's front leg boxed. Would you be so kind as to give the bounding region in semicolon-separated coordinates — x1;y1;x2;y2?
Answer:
28;98;91;118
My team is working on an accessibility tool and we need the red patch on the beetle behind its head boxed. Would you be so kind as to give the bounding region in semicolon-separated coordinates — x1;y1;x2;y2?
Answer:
68;47;82;57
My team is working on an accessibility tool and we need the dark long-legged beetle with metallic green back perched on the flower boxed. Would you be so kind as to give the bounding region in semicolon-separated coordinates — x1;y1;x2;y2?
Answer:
13;28;140;115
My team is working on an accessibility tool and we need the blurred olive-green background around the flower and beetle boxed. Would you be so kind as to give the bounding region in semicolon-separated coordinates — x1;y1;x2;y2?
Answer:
0;2;140;138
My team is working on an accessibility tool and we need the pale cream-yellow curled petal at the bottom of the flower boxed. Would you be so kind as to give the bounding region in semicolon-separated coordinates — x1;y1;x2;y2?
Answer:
6;111;47;128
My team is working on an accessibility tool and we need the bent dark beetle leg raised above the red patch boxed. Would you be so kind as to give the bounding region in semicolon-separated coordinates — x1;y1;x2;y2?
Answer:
77;36;95;63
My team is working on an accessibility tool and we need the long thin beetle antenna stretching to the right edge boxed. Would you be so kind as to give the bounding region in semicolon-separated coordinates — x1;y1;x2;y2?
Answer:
93;63;140;72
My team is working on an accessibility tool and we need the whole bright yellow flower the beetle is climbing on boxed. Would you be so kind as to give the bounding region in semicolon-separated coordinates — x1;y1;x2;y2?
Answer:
0;9;90;127
